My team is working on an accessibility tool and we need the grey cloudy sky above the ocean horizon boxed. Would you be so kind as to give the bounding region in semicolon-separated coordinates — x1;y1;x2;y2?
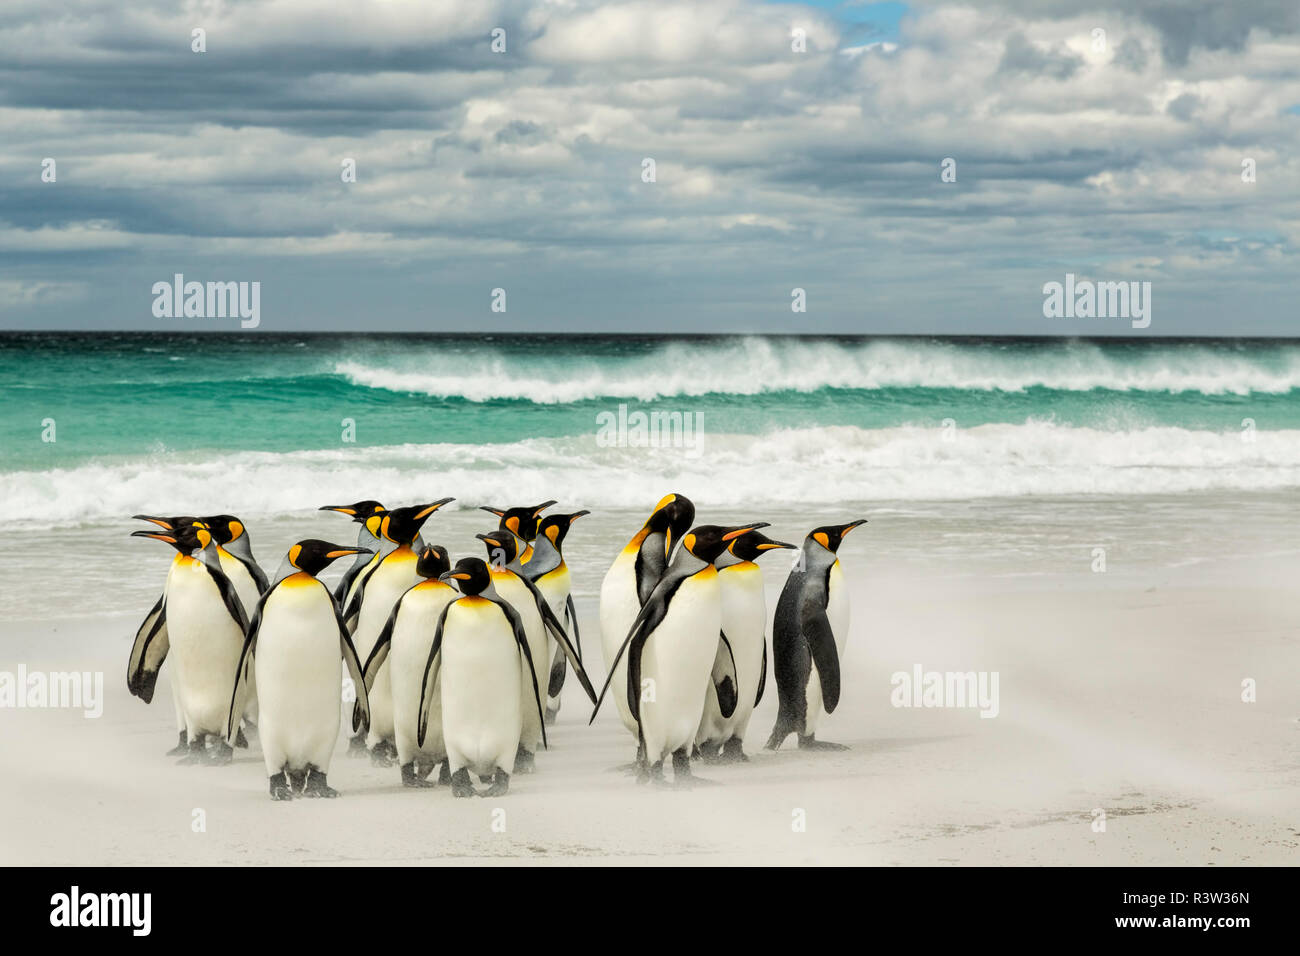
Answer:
0;0;1300;336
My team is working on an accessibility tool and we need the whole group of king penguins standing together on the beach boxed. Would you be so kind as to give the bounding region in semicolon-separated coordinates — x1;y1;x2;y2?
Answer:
127;494;865;800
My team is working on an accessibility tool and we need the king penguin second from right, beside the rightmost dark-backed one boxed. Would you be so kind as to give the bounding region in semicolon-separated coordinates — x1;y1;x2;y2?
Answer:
696;531;794;762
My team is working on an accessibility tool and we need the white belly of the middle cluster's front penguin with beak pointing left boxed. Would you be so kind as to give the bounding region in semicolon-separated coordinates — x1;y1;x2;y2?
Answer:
441;600;523;775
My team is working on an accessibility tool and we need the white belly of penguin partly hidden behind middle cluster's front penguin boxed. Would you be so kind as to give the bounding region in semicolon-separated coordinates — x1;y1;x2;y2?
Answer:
387;581;459;765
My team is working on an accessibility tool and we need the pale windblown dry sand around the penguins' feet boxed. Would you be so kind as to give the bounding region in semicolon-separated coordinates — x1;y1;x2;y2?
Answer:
0;554;1300;865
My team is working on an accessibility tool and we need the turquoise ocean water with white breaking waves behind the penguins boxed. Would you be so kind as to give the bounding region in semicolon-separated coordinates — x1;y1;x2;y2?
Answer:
0;333;1300;523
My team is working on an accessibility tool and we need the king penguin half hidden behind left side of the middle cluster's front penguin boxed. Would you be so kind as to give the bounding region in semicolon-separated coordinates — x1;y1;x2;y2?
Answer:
365;545;460;787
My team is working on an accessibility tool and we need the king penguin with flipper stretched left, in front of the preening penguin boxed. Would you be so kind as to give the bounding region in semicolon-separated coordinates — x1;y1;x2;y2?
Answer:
592;522;767;787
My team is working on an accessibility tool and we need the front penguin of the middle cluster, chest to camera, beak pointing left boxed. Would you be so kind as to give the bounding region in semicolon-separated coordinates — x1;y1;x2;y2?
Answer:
417;558;545;797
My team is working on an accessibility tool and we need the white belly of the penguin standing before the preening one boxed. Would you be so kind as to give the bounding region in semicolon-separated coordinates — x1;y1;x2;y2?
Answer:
639;567;722;763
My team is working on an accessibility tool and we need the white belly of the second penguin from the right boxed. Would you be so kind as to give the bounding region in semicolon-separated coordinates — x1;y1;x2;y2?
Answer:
697;562;767;744
